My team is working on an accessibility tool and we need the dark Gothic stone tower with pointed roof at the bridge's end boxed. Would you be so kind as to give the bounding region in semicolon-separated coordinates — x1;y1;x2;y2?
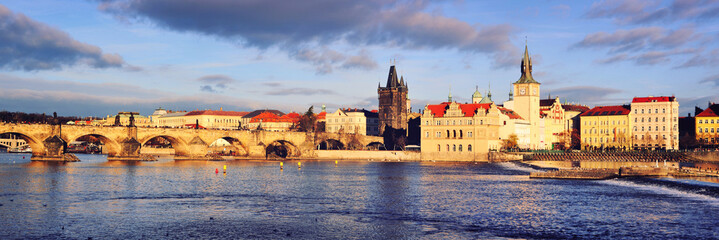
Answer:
377;65;410;148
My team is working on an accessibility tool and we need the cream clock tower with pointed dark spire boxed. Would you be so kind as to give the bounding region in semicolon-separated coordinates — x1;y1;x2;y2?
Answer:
513;45;541;148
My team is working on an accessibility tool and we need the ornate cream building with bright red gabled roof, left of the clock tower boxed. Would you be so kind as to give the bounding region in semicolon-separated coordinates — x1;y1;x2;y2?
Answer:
420;100;502;160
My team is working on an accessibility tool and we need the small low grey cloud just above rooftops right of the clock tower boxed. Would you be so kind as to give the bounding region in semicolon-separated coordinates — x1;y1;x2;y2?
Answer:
549;86;622;105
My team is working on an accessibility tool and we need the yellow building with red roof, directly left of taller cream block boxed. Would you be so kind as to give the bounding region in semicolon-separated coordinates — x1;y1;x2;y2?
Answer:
579;105;631;150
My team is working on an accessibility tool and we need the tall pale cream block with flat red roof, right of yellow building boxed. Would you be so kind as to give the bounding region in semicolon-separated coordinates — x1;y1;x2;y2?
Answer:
630;96;679;150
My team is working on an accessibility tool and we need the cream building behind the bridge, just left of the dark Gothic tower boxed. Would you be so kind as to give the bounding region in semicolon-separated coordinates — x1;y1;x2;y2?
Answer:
325;108;379;136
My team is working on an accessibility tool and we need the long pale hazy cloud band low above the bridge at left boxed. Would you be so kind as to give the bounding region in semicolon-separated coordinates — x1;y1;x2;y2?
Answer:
0;74;300;117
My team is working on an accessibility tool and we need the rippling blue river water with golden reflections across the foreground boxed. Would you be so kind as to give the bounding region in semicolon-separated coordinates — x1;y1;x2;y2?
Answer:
0;153;719;239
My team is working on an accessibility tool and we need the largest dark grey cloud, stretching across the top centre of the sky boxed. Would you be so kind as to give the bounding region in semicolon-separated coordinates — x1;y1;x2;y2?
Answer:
99;0;520;70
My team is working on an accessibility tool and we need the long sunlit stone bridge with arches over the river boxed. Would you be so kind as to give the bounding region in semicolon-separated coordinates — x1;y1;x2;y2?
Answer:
0;123;384;161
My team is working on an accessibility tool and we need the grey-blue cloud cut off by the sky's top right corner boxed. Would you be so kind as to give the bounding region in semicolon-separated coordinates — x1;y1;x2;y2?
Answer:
585;0;719;24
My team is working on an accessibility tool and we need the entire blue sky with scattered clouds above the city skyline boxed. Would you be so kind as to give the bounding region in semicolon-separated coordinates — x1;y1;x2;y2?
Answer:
0;0;719;116
